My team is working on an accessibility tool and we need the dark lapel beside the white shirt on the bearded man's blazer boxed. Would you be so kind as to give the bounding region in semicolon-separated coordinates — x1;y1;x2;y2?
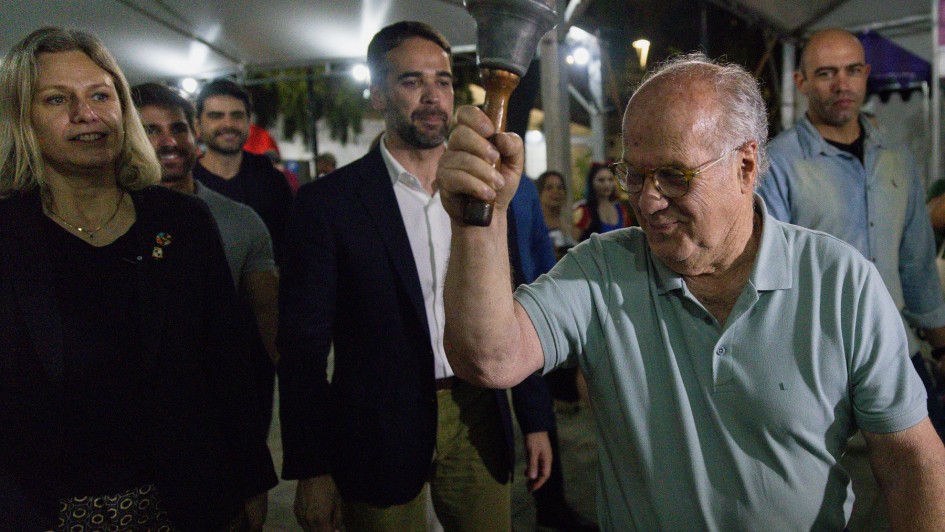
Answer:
357;148;429;331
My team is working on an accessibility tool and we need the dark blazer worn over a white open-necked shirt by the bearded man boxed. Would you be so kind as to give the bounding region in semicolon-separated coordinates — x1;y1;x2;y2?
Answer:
279;147;554;505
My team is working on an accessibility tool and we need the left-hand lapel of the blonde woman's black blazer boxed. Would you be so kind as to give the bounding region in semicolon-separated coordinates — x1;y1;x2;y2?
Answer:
3;192;65;384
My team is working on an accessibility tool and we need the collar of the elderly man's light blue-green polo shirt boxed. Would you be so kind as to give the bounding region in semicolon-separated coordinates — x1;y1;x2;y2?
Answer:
647;194;793;295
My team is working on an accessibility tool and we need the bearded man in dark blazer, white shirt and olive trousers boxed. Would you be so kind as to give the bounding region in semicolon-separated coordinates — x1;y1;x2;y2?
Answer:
278;22;554;530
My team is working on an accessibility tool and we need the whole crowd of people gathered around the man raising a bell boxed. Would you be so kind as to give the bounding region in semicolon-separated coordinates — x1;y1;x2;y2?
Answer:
0;16;945;531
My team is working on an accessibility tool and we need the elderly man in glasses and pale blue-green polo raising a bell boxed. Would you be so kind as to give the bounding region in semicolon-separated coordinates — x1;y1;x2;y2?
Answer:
438;54;945;530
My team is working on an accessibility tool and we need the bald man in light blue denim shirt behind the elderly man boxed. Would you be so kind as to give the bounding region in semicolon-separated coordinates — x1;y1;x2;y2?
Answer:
759;29;945;436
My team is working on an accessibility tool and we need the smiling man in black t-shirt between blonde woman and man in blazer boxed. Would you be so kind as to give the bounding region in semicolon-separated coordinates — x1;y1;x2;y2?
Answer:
194;79;292;264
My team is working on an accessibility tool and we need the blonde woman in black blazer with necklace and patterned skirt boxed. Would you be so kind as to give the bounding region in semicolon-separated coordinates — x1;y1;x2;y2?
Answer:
0;28;276;530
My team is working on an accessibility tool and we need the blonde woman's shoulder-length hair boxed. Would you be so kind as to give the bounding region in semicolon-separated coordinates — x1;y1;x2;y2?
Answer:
0;27;161;196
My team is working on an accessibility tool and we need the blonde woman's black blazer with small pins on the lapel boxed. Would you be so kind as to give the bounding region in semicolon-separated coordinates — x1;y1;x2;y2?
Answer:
0;187;276;530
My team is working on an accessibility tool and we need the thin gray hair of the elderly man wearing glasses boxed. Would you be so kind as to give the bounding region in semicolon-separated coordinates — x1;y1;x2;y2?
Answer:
636;52;768;177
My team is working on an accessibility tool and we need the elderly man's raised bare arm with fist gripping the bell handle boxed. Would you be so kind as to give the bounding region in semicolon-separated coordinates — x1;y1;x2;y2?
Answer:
437;106;544;388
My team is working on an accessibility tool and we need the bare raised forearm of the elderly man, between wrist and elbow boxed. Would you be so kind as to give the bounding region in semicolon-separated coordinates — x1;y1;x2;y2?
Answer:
444;212;529;388
